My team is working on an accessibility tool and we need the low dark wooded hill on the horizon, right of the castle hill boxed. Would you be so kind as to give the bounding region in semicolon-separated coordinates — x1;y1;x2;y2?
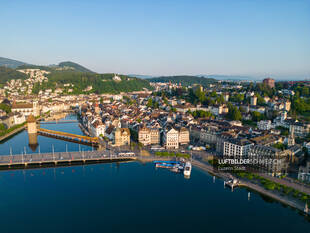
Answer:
148;75;217;86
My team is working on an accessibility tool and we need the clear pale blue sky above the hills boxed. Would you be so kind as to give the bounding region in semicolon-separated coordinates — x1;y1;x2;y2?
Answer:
0;0;310;79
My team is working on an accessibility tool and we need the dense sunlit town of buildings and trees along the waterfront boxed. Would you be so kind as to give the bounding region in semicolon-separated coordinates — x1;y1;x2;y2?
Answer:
0;62;310;211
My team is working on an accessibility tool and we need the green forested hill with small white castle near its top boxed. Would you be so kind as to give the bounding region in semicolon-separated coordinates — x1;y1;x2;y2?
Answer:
33;70;151;94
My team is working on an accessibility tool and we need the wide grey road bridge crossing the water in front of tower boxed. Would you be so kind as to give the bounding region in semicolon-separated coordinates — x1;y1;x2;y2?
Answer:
0;151;137;170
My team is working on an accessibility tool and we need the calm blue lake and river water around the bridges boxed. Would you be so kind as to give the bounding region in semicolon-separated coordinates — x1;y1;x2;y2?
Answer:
0;114;310;233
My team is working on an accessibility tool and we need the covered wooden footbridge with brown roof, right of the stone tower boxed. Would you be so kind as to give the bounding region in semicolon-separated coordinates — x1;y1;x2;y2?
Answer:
37;128;99;146
